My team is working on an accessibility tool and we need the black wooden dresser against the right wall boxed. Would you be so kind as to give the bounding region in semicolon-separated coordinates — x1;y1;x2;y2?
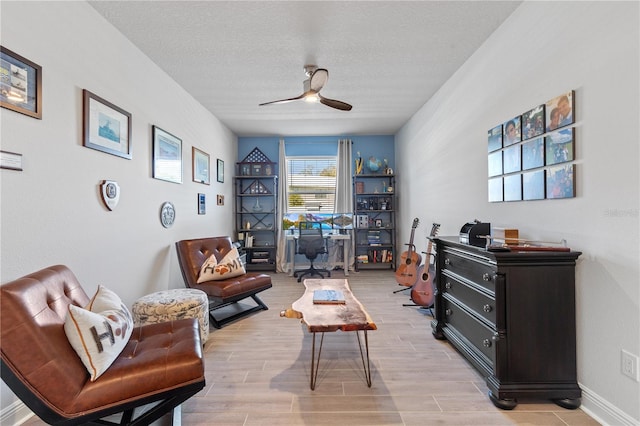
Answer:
431;237;582;409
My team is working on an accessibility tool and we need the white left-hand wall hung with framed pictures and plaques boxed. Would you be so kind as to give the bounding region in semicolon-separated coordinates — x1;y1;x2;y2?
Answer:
0;1;237;423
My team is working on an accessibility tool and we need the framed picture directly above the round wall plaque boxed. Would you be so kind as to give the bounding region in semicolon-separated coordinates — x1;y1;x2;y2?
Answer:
153;126;182;183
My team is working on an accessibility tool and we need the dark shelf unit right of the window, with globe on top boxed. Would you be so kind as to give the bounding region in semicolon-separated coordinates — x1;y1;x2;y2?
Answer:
353;174;397;271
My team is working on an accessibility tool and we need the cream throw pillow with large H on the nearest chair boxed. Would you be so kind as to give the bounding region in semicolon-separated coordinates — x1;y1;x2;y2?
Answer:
64;286;133;382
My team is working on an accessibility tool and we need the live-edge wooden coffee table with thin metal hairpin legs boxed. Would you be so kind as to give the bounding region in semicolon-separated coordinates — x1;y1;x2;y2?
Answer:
280;278;377;390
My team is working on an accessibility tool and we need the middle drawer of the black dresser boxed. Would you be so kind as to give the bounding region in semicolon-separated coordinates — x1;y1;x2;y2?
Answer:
442;270;496;328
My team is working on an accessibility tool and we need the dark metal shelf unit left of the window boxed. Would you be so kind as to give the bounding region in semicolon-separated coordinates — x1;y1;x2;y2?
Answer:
235;175;278;271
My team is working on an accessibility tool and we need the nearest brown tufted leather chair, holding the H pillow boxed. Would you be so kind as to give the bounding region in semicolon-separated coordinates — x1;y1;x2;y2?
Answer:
0;265;205;425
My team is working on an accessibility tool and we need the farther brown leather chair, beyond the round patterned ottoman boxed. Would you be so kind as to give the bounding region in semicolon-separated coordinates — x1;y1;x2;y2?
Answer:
176;237;272;328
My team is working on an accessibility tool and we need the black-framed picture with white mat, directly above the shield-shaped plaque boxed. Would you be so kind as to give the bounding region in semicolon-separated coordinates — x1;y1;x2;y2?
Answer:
82;89;131;160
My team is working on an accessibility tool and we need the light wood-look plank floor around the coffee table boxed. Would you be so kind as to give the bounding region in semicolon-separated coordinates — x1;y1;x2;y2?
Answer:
21;271;598;426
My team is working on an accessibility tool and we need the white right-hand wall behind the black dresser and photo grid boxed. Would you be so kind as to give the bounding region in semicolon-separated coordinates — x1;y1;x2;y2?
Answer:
396;2;640;424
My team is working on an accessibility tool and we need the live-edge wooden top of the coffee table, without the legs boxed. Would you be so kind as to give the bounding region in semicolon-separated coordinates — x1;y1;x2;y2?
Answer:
282;278;377;333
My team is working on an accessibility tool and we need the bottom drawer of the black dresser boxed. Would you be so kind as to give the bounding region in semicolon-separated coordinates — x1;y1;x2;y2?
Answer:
444;295;496;368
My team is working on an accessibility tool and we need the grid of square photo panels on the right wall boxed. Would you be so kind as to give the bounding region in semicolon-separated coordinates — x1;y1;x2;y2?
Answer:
487;90;576;202
